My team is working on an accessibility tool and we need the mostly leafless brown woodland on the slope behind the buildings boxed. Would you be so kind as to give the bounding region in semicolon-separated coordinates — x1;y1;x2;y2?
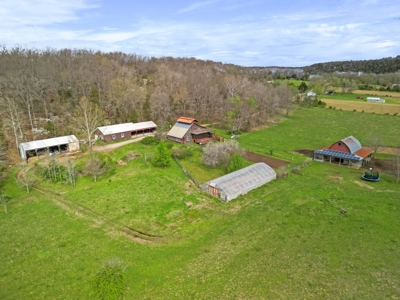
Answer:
0;47;293;157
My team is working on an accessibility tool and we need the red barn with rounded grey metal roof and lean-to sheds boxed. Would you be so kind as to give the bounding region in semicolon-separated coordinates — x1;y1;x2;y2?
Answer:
314;136;371;168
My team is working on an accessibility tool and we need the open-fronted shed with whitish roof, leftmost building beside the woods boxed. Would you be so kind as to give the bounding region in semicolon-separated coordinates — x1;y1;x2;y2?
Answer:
18;135;80;159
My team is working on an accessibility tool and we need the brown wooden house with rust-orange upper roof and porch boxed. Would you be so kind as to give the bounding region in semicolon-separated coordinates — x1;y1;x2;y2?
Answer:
167;117;214;144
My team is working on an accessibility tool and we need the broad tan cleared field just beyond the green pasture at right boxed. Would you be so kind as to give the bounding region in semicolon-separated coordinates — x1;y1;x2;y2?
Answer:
321;98;400;115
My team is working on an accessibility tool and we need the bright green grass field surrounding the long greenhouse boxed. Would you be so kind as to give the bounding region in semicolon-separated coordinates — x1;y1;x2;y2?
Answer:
0;108;400;299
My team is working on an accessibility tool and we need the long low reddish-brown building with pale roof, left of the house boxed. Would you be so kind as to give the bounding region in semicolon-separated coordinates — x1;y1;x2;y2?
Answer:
94;121;157;142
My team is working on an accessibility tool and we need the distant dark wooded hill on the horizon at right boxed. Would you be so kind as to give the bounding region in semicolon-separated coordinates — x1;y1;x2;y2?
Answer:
302;55;400;74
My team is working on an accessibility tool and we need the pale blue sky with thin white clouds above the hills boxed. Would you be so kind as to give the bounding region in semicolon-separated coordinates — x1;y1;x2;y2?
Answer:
0;0;400;67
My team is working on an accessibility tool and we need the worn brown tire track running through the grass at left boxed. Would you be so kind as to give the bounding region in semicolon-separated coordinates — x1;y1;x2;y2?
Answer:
16;167;164;243
